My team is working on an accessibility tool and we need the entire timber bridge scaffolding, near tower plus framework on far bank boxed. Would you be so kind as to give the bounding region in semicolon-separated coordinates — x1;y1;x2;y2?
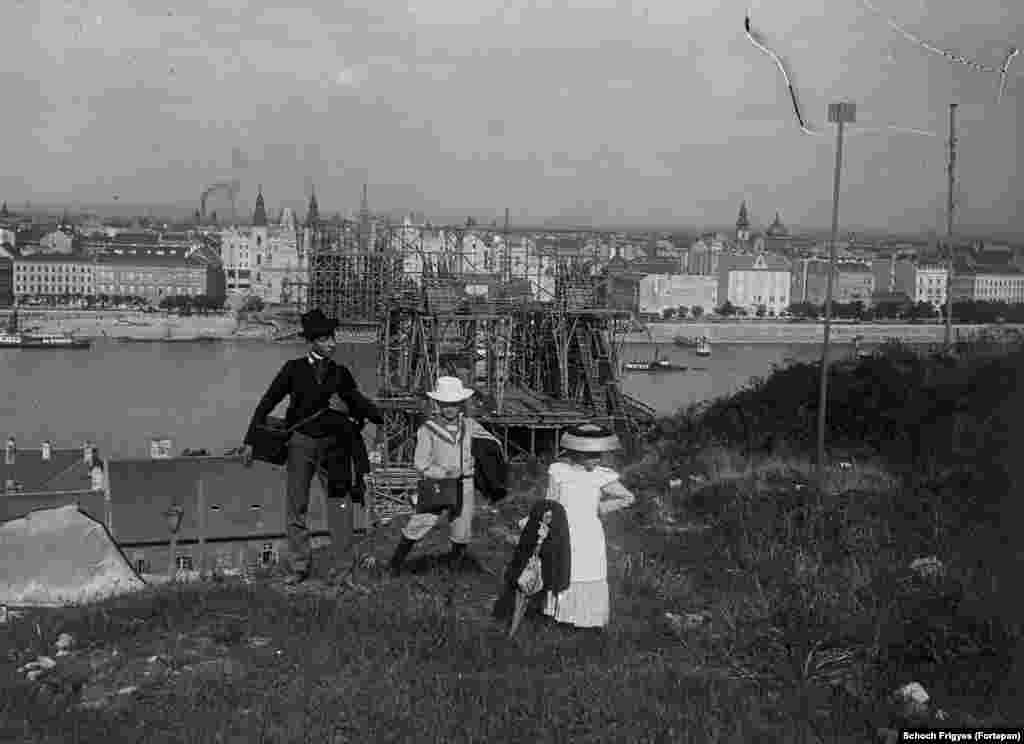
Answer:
299;217;653;465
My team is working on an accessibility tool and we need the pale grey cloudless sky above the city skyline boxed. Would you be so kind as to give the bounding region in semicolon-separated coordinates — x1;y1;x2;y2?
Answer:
0;0;1024;232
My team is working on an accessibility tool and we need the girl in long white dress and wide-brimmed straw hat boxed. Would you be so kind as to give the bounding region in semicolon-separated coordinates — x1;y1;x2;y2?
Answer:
544;424;636;628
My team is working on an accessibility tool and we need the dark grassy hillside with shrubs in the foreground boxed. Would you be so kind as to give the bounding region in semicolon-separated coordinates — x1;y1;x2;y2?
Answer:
0;350;1024;743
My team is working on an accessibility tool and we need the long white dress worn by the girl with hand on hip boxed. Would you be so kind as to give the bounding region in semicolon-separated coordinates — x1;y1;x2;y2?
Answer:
544;463;618;627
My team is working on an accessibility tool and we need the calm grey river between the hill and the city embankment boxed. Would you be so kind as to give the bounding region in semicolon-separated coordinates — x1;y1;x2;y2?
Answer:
0;341;872;457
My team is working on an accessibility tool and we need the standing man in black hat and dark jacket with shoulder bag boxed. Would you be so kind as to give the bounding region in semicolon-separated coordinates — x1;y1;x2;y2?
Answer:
242;308;383;584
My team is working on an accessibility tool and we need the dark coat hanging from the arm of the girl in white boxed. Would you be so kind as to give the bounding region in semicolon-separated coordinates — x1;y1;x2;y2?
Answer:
494;498;572;620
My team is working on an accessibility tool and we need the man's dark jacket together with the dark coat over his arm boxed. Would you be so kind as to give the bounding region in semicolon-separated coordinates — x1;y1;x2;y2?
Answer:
245;357;384;501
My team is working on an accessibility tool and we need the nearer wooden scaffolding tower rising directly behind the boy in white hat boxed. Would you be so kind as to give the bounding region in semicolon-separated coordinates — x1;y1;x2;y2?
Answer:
378;292;653;464
